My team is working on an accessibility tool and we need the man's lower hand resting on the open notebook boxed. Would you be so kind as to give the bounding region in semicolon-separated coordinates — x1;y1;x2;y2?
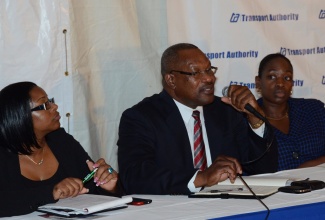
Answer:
194;156;242;187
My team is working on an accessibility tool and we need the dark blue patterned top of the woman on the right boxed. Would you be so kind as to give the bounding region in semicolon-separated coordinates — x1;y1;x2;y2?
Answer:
258;98;325;170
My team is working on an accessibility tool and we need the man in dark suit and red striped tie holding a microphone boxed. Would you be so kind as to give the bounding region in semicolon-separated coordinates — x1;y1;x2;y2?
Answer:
117;43;277;194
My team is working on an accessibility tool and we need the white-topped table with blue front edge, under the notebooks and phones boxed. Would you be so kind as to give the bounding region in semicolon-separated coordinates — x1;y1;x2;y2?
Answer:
8;164;325;220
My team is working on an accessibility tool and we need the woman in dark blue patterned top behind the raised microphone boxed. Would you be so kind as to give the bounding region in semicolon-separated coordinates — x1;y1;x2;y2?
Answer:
255;53;325;170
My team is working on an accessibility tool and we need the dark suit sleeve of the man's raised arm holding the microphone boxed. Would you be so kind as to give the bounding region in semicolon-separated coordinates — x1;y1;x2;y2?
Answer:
204;97;278;175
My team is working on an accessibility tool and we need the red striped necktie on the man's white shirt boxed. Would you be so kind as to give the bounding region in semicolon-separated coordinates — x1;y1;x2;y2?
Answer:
192;111;207;170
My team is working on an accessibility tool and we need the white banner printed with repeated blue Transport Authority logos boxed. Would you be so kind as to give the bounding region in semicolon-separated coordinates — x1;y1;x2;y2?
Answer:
167;0;325;99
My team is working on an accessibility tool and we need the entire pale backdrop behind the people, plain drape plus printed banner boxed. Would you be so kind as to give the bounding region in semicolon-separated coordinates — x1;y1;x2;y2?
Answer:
0;0;325;169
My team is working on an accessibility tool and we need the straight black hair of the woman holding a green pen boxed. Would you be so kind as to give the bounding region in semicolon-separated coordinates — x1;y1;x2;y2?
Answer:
0;82;40;155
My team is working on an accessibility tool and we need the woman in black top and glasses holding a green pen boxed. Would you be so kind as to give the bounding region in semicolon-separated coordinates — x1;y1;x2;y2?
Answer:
0;82;120;217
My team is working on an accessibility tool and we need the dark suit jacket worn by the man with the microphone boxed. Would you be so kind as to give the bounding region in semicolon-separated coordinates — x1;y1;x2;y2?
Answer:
117;91;277;194
